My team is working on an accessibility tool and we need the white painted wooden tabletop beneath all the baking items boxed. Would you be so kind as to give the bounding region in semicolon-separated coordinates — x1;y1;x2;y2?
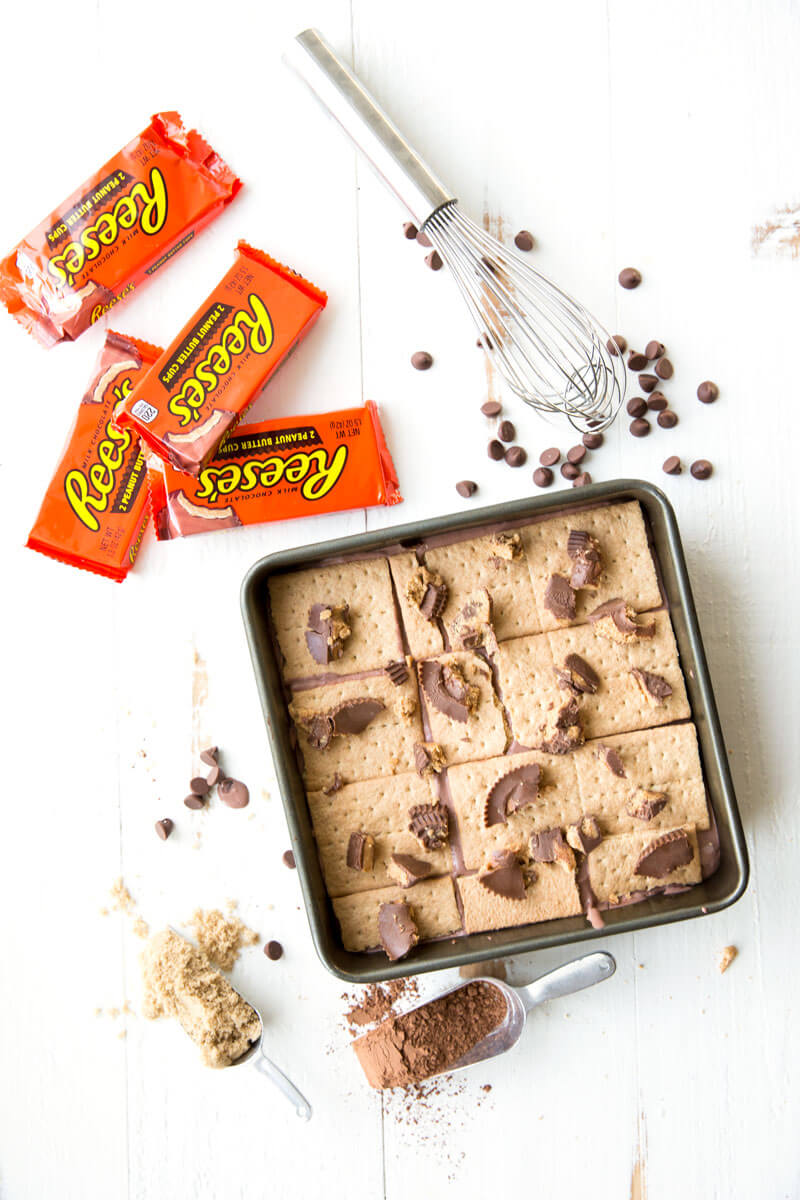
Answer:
0;0;800;1200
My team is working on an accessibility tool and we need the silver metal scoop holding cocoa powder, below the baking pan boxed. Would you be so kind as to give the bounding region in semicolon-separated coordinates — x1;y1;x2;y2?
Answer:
417;950;616;1078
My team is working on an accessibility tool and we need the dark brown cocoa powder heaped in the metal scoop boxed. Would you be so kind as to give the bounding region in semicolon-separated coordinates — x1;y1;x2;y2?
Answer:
353;983;507;1088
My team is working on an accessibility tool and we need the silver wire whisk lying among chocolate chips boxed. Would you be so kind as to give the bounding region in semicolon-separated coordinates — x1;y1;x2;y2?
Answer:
285;29;625;431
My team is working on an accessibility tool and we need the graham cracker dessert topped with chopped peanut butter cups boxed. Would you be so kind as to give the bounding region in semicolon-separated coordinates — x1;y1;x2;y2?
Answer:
270;502;718;961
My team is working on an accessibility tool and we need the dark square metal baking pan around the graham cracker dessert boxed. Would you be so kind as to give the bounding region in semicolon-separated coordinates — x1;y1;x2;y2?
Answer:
241;479;748;983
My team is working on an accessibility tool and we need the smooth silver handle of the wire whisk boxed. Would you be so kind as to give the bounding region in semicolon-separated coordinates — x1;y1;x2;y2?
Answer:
284;29;455;226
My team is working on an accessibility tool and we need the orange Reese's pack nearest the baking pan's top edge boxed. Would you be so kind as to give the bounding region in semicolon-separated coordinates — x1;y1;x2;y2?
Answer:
148;402;403;541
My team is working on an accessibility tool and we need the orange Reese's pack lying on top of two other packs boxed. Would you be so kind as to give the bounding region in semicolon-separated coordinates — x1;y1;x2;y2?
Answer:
115;241;327;476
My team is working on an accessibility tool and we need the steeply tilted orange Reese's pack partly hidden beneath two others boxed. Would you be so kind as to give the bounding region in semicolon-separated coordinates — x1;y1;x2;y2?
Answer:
28;330;161;582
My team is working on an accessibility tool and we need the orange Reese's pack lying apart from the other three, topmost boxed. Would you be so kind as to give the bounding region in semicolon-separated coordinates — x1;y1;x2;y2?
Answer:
0;113;241;347
